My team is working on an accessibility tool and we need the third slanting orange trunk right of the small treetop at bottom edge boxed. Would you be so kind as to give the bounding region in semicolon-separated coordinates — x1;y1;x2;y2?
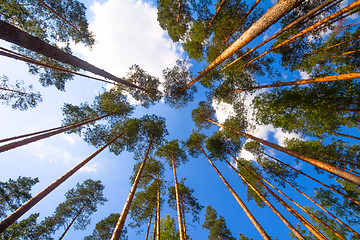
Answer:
232;156;327;239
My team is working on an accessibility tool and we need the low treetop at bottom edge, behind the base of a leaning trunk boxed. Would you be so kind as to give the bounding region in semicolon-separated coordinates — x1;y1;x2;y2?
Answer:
84;213;128;240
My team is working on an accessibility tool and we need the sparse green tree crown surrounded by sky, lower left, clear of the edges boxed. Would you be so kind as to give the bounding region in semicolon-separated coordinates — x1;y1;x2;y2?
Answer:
53;179;107;230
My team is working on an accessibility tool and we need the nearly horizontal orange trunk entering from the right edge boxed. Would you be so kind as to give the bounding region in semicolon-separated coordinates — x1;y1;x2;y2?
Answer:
232;72;360;93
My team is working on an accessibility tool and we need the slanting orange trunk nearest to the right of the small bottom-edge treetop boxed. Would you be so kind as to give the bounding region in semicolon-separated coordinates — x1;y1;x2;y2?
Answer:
200;147;270;240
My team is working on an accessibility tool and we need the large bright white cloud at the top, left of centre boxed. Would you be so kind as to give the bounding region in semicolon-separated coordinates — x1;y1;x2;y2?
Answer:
73;0;182;81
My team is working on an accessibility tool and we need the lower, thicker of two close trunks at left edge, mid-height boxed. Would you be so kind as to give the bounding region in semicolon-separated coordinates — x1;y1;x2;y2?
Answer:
0;115;109;153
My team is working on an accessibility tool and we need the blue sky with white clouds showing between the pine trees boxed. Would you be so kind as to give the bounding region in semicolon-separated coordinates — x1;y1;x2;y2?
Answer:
0;0;360;239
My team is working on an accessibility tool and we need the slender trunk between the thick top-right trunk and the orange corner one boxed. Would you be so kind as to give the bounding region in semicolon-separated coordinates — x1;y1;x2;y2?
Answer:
220;0;335;71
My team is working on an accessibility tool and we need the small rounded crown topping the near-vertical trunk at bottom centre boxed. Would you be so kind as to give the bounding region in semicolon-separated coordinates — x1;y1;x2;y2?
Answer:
156;139;189;168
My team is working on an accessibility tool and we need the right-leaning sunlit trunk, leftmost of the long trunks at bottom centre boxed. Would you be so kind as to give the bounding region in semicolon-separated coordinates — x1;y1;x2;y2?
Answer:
111;137;154;240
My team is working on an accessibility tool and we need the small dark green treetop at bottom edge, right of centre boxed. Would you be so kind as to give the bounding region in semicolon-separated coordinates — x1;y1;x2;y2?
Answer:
202;205;236;240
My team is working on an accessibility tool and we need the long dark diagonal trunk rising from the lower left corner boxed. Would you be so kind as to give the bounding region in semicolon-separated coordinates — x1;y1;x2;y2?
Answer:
0;132;121;234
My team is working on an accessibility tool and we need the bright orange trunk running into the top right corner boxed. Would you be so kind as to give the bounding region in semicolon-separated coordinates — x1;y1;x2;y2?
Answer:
245;1;360;66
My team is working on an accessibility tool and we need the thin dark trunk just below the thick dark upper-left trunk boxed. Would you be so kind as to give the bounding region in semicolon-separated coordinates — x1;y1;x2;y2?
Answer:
0;47;114;85
